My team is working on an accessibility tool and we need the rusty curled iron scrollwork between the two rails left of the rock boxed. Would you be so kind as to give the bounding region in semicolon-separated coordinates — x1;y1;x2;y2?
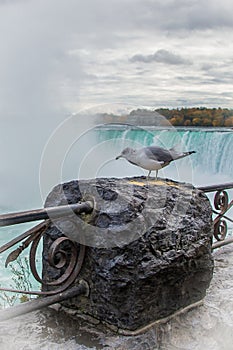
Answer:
0;220;85;295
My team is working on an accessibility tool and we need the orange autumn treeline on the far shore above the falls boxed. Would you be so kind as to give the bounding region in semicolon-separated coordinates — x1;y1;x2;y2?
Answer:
155;107;233;127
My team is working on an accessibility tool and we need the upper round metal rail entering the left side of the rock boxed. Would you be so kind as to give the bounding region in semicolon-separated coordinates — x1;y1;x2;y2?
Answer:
0;201;93;226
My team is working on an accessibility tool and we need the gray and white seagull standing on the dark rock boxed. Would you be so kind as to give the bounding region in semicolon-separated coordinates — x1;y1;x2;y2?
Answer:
116;146;196;180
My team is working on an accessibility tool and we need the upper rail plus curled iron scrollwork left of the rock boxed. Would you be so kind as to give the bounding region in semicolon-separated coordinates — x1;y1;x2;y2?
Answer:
0;201;94;296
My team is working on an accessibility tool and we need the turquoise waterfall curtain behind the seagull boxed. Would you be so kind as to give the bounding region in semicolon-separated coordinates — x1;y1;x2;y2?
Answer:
99;126;233;186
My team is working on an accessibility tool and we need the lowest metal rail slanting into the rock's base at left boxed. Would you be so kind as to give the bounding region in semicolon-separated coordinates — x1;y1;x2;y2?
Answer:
0;283;88;322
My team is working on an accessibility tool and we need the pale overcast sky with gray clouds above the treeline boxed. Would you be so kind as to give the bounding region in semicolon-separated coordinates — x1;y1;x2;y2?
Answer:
0;0;233;116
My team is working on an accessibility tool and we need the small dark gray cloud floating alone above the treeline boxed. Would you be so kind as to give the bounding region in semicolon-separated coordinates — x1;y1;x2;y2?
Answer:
130;49;191;65
